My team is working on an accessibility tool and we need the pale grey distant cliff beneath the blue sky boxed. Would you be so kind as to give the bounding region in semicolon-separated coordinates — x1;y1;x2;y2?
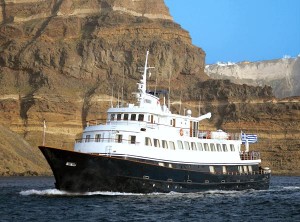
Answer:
205;57;300;98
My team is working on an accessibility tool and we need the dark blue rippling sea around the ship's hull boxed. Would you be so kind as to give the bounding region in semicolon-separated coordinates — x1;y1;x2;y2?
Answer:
0;176;300;222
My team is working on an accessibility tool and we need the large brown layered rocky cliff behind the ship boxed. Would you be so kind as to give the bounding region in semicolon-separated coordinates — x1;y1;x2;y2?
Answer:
0;0;300;175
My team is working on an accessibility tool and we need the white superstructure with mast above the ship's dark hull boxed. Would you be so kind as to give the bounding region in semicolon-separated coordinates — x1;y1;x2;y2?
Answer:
74;52;261;167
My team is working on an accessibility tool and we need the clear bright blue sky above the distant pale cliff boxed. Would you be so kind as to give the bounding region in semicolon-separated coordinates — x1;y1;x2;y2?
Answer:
164;0;300;64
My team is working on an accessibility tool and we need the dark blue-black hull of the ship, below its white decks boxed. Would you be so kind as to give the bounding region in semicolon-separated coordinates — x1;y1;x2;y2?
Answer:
39;146;270;193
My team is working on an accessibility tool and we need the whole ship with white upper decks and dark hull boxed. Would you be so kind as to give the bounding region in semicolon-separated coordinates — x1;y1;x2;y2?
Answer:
39;51;271;193
